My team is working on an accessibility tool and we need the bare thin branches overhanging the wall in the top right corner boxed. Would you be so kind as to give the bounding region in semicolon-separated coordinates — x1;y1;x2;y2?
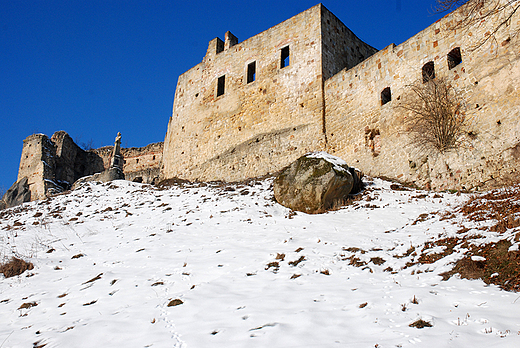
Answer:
436;0;520;50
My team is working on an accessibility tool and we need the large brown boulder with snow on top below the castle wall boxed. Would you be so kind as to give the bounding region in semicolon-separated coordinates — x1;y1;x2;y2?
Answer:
274;152;363;214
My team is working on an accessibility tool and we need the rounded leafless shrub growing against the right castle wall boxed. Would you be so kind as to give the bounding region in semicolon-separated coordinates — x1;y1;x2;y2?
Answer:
399;78;469;153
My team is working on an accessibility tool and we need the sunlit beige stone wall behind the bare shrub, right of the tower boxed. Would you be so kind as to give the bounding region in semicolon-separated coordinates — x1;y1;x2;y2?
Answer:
325;3;520;190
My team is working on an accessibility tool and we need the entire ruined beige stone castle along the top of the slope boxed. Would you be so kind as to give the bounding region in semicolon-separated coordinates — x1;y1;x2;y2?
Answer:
3;0;520;207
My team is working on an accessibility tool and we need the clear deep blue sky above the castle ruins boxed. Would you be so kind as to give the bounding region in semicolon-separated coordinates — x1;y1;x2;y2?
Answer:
0;0;441;189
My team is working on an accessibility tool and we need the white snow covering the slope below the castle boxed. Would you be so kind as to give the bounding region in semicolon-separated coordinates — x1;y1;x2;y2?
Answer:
0;179;520;348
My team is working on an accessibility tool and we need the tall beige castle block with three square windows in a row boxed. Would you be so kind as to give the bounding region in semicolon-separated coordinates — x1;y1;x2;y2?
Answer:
162;4;375;181
